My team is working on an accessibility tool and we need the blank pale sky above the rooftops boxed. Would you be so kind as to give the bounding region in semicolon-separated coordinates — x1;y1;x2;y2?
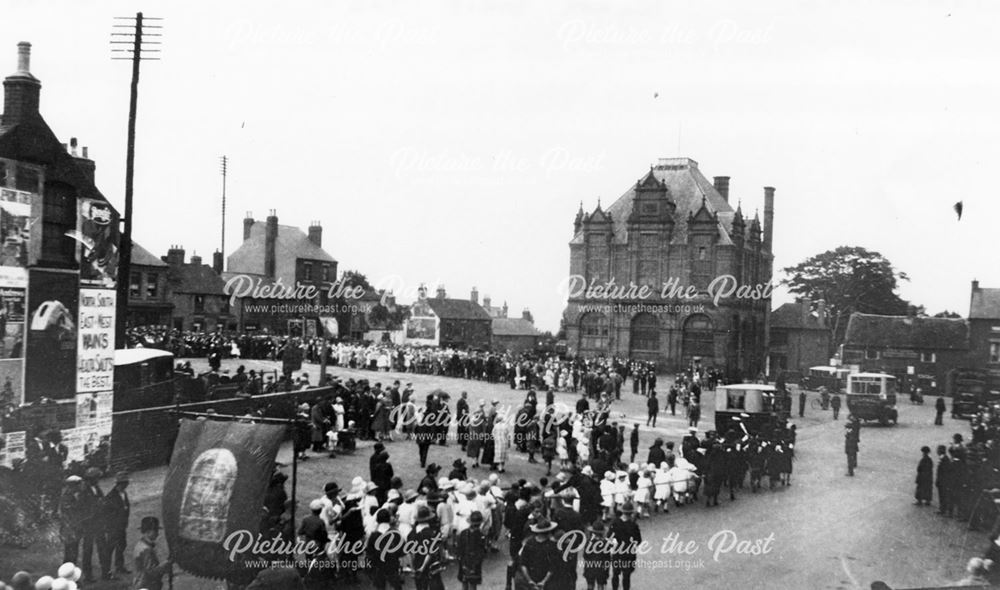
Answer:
0;0;1000;331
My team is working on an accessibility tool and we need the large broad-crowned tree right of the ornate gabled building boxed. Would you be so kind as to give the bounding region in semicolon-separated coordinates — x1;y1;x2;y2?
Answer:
781;246;923;343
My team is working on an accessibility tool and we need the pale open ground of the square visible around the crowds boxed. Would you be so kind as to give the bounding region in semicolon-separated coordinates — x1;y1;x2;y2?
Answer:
64;361;985;590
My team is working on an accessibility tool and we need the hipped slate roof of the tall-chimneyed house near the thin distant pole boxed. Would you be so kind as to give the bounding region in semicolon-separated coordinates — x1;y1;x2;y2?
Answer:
226;221;337;285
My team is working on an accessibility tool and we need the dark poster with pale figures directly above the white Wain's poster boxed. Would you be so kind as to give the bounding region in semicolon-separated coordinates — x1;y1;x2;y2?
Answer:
73;199;120;289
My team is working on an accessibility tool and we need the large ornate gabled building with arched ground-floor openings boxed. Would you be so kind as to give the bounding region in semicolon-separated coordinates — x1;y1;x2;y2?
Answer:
564;158;774;378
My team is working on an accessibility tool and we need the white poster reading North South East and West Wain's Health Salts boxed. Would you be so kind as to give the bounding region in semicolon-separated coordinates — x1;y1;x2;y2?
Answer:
76;289;117;393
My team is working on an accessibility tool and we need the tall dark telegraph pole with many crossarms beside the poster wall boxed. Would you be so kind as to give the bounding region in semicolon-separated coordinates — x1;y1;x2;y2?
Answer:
111;12;163;348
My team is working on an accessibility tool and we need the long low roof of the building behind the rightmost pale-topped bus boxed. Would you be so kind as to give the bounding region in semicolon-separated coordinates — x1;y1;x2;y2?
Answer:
844;313;969;350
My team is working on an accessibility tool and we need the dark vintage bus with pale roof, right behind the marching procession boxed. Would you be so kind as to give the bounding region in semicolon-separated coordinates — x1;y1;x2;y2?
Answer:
715;383;791;435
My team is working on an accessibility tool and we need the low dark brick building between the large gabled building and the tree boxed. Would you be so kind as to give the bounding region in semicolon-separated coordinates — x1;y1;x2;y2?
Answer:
768;299;833;377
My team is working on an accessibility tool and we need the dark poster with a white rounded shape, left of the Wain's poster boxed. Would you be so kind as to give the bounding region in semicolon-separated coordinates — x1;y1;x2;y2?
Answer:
24;270;80;403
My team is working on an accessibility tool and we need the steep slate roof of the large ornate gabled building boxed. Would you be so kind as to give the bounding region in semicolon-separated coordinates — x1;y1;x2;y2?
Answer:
570;158;750;245
